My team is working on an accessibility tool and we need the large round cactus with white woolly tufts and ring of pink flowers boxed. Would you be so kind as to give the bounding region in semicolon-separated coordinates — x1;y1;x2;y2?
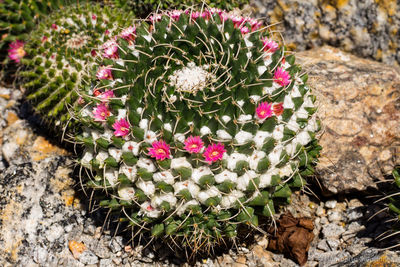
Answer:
76;9;320;255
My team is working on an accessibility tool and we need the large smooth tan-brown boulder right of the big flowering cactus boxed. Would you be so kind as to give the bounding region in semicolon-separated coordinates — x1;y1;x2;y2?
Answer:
297;46;400;195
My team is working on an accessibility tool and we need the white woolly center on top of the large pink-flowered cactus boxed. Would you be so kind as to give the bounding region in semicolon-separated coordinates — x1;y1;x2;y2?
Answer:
169;62;215;94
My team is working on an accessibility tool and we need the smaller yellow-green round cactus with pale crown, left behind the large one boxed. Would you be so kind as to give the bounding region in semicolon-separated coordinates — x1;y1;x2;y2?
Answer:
19;4;131;127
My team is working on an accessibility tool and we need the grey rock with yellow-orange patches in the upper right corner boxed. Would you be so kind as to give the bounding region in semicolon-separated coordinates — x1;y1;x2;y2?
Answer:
250;0;400;65
